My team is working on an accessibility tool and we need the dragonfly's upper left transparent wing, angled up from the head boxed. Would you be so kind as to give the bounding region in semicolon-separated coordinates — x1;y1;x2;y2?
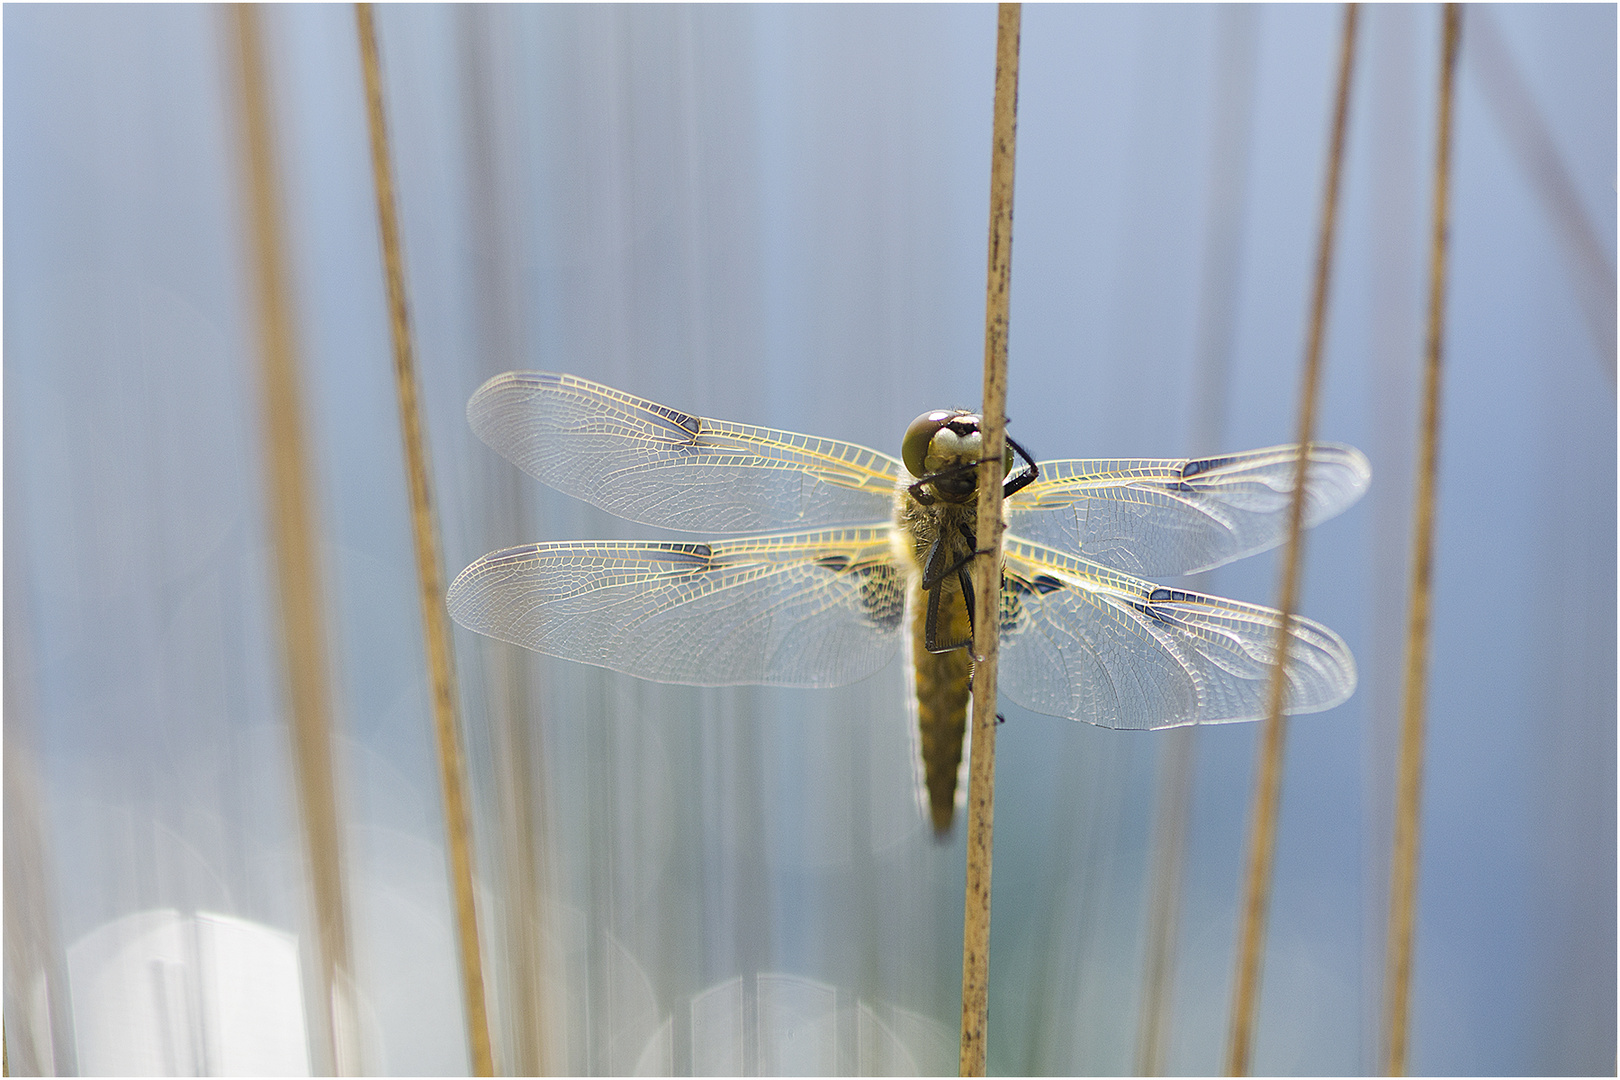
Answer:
467;371;901;533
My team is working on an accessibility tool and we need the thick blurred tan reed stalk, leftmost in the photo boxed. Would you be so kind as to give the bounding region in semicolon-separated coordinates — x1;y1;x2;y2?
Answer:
230;3;360;1075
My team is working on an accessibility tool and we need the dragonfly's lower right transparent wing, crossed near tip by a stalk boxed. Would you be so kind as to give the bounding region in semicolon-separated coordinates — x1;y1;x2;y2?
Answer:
1000;536;1356;729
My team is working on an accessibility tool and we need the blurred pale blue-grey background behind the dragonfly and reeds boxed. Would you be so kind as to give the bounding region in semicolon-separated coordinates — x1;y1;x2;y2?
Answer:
3;5;1617;1074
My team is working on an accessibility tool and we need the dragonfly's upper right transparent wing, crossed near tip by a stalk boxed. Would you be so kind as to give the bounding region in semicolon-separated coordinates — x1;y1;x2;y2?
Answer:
1008;442;1372;576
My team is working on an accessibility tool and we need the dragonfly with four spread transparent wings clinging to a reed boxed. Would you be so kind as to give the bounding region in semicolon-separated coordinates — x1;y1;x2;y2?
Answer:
447;372;1371;836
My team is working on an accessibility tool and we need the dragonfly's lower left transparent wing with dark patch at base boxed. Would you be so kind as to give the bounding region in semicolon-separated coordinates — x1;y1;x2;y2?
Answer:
449;525;906;687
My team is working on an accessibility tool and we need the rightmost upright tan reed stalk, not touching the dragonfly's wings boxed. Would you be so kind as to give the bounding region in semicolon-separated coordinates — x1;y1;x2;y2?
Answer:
1383;3;1463;1077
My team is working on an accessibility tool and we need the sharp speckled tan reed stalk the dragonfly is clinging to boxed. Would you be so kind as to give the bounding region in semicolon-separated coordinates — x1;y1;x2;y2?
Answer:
959;3;1022;1077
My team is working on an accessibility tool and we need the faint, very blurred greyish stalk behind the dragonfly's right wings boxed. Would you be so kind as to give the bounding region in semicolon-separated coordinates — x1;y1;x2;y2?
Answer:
1136;3;1259;1077
